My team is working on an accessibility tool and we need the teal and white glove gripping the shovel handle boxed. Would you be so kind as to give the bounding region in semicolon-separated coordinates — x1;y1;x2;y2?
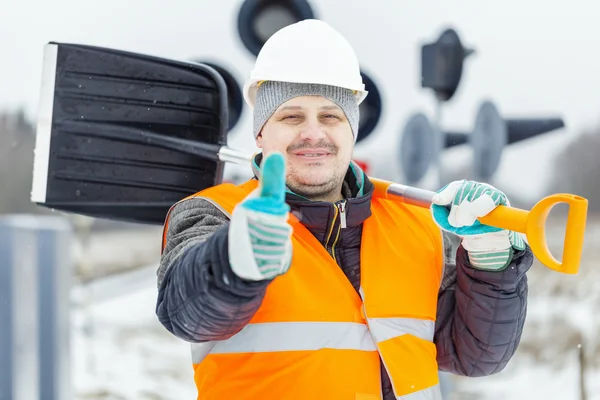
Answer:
431;180;525;271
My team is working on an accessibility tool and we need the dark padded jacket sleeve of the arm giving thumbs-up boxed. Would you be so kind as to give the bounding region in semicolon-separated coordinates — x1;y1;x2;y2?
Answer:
156;198;270;343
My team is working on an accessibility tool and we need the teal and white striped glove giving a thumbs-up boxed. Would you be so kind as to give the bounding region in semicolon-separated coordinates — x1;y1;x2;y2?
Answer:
229;153;292;281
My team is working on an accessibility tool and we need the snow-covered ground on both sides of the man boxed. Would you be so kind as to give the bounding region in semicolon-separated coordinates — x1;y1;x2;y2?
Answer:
72;217;600;400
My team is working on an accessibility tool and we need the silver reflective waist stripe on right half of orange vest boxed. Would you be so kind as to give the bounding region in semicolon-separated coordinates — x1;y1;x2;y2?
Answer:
368;318;435;343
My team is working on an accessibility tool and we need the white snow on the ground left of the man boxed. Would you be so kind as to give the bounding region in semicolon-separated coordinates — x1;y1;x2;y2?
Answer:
72;268;196;400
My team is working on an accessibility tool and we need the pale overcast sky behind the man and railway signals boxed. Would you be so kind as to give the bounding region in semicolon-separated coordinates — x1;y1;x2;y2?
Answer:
0;0;600;198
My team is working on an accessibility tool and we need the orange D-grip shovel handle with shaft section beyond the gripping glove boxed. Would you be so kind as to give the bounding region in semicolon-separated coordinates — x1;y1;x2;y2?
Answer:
369;177;588;274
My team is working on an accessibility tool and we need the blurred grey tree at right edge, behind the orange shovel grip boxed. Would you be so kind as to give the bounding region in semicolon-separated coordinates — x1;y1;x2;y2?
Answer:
548;126;600;212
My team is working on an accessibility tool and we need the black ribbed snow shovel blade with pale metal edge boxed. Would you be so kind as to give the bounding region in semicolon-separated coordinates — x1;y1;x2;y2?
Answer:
31;42;228;224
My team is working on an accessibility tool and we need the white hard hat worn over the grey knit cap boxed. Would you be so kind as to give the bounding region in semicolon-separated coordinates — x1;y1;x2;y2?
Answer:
244;19;368;108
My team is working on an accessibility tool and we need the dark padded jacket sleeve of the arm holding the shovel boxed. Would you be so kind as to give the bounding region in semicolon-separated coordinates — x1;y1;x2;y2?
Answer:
434;233;533;377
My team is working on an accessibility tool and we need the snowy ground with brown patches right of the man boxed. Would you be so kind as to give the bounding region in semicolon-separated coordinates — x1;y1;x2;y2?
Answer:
452;215;600;400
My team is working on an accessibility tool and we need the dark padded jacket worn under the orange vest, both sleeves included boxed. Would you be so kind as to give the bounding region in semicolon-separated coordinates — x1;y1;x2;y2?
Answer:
156;157;533;399
